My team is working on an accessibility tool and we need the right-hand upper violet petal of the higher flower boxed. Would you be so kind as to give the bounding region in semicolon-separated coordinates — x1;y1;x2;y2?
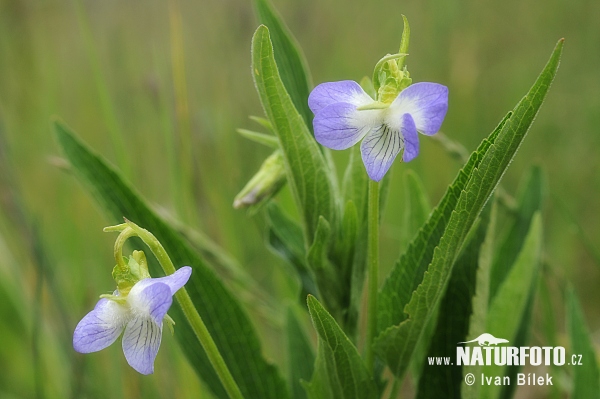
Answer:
389;82;448;135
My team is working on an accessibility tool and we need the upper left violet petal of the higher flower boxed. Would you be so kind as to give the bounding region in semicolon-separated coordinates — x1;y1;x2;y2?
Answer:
308;80;373;114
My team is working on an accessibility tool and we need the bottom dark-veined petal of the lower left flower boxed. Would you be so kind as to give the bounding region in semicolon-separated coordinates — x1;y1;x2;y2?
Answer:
123;316;162;375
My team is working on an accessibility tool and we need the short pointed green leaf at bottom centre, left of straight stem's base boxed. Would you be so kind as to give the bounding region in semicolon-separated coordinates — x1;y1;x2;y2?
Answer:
308;296;378;399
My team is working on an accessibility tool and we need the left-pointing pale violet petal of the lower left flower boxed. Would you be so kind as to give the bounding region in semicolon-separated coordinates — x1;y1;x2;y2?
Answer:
73;298;130;353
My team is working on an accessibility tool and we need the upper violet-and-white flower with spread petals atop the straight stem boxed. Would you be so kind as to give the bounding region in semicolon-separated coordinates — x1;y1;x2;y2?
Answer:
308;80;448;181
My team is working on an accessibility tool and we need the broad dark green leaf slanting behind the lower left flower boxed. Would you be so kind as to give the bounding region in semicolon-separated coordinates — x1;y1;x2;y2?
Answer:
54;122;289;399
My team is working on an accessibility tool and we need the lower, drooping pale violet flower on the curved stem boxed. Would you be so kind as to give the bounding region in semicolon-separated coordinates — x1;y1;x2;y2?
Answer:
73;266;192;374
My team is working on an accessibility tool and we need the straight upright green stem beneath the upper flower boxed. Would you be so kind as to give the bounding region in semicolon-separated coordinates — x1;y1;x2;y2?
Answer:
366;180;379;372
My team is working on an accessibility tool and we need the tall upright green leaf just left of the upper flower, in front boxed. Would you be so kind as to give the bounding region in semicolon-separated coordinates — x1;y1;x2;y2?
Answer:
252;25;338;243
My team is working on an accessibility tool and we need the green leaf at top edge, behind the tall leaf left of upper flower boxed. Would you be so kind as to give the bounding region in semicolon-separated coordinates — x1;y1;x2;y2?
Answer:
254;0;312;129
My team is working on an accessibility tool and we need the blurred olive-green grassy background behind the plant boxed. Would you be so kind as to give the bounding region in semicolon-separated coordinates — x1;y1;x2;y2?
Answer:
0;0;600;398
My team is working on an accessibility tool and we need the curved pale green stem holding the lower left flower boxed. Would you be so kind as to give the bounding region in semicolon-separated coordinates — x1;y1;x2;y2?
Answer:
127;221;243;399
